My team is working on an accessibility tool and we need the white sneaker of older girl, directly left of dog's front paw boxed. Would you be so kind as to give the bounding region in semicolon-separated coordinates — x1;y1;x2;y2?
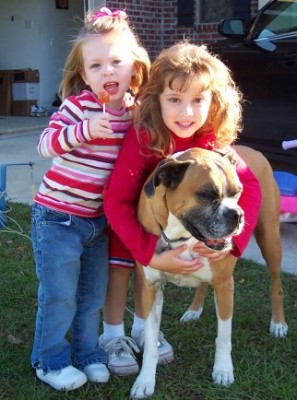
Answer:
99;335;139;376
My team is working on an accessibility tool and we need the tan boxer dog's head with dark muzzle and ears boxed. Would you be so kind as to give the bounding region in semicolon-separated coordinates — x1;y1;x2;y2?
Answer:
144;148;244;250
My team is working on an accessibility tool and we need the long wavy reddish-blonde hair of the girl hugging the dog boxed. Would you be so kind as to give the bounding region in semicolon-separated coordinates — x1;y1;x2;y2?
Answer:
134;41;242;156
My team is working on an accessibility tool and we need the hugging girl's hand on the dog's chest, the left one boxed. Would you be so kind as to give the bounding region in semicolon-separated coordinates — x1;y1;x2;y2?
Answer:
149;245;203;275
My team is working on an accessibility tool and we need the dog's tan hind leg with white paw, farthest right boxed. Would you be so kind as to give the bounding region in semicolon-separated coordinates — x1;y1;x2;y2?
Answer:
255;173;288;337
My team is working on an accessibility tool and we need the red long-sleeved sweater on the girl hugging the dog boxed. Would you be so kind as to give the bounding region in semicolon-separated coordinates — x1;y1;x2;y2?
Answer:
104;128;261;265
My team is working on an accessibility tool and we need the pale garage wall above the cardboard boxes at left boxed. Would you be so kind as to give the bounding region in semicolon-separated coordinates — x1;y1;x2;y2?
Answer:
0;0;84;107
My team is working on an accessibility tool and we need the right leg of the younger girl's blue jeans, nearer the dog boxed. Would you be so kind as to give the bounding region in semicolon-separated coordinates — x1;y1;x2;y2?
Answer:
71;217;108;369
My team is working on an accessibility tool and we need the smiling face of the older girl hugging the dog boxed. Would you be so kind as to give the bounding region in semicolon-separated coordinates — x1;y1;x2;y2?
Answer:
160;75;211;138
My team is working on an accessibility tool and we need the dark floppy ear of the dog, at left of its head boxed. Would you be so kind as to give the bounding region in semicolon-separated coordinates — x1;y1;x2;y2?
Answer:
144;158;193;197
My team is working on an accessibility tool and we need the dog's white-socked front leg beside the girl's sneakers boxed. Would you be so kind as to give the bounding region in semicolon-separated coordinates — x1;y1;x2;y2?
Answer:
130;282;163;399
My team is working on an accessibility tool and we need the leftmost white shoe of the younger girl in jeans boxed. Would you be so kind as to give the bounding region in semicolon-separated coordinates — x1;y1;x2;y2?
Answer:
36;365;87;391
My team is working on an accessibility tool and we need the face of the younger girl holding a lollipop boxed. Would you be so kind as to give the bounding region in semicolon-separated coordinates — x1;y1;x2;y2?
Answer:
82;32;135;109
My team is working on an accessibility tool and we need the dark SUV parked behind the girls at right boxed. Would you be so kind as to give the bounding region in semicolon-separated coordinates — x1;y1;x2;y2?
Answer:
212;0;297;170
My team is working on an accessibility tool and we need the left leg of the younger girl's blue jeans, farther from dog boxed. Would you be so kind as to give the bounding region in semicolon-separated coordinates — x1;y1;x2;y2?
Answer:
31;205;107;371
